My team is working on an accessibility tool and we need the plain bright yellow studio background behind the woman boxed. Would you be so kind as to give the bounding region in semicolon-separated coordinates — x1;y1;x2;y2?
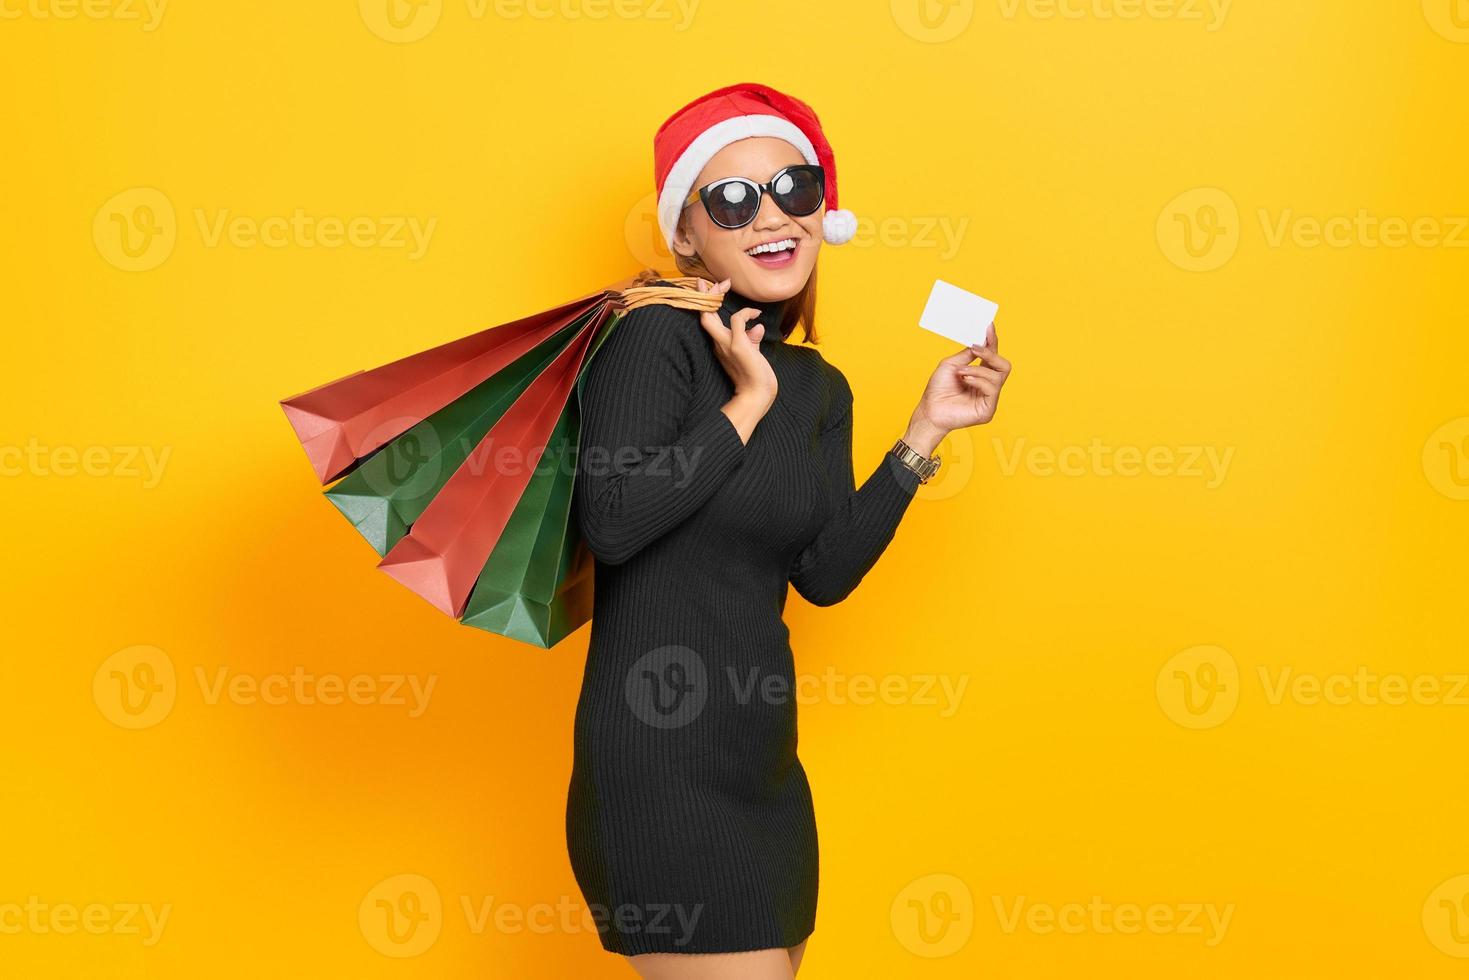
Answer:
0;0;1469;979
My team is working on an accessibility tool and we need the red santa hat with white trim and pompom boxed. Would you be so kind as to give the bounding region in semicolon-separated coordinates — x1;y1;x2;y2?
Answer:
652;82;856;251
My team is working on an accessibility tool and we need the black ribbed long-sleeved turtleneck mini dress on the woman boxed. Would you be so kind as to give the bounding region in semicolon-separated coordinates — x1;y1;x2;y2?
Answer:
566;291;918;955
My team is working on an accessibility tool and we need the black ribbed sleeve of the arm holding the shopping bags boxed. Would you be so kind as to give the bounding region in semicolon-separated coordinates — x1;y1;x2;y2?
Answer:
576;306;745;564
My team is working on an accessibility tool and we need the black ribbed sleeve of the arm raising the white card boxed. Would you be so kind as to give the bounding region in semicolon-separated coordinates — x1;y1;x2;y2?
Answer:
790;367;918;605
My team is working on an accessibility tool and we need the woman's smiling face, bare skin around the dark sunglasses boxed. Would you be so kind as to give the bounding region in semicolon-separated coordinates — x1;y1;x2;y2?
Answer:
673;137;826;303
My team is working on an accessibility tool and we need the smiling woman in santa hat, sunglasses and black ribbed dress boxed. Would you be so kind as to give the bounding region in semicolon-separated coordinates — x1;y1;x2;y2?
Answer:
566;84;1009;980
